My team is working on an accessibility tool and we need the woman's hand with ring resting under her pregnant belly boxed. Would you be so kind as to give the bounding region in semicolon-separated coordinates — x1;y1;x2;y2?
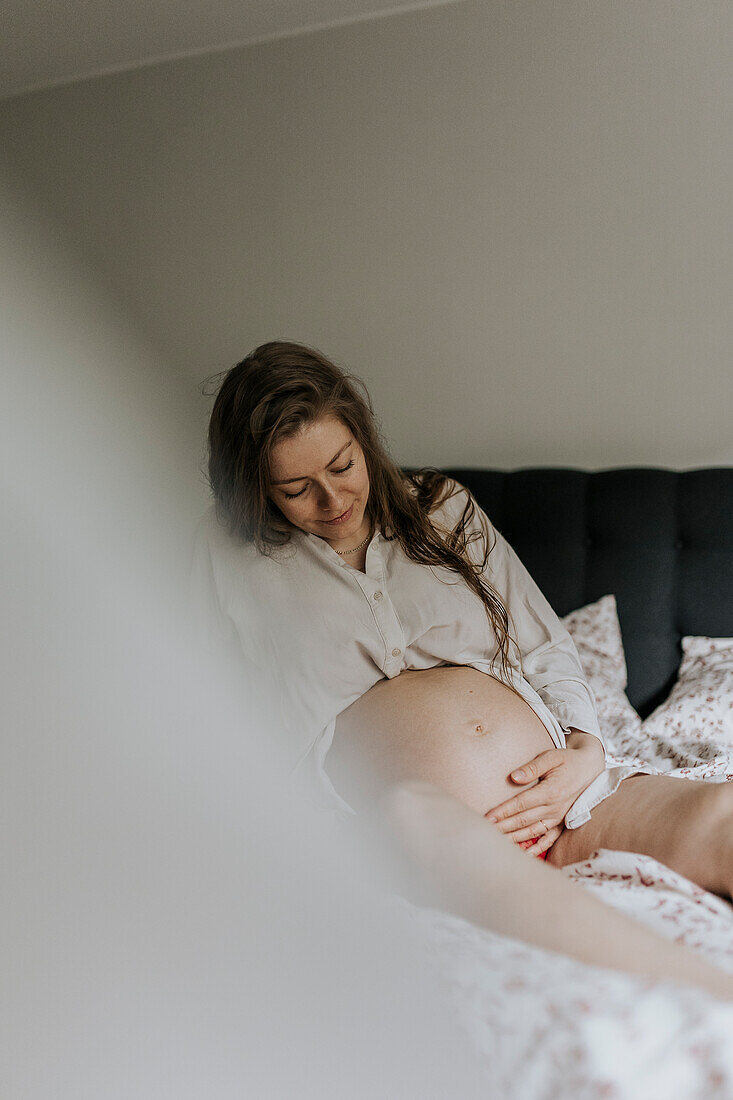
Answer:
485;730;605;856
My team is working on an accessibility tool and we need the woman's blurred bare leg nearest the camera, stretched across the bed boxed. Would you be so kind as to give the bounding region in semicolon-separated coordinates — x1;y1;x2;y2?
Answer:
379;782;733;999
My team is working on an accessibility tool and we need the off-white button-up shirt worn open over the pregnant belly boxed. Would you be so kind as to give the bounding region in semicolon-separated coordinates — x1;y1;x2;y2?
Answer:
193;483;617;825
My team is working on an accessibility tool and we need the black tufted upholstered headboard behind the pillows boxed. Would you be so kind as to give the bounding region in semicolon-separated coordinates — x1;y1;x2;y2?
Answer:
433;466;733;717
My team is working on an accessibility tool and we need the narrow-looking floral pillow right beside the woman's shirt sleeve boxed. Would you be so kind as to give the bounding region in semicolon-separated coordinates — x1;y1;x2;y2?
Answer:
561;596;642;757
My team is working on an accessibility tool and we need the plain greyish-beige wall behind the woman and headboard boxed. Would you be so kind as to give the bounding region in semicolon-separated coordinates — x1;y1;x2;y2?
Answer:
0;0;733;506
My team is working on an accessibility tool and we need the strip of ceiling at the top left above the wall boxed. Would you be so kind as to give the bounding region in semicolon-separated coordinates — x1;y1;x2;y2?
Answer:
0;0;456;97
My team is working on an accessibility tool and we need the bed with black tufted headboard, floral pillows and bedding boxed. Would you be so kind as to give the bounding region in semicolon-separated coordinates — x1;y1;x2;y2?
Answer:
396;466;733;1100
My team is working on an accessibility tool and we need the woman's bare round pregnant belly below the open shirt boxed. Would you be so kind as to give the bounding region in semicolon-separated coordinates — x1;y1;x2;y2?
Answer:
326;666;554;813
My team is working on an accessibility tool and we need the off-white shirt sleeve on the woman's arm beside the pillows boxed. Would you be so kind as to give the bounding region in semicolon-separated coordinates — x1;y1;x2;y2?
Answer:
444;483;605;749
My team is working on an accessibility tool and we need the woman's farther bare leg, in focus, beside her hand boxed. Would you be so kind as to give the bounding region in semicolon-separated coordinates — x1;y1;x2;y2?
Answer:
547;776;733;897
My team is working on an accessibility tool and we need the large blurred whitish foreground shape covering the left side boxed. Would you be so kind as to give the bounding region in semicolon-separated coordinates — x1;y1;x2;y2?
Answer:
0;182;485;1100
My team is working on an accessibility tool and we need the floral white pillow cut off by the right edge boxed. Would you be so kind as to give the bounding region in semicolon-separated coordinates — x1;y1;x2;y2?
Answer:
642;636;733;765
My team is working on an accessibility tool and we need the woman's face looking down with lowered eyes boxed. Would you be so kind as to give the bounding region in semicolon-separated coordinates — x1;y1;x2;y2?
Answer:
270;414;370;549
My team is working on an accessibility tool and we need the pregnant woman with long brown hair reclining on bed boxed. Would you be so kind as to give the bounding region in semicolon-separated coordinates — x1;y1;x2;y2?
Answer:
195;342;733;994
